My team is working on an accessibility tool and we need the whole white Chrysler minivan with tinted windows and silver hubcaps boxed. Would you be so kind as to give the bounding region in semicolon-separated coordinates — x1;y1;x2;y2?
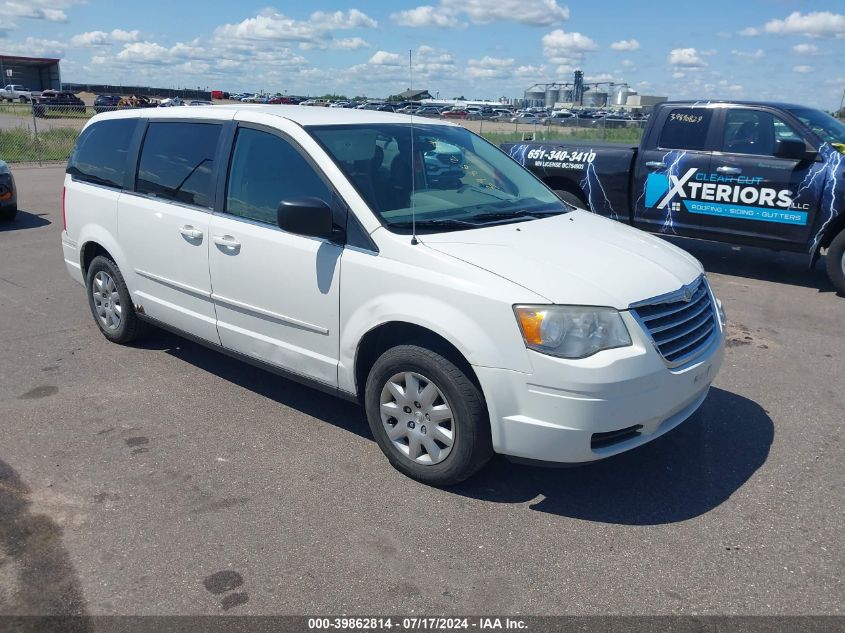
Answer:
62;105;725;485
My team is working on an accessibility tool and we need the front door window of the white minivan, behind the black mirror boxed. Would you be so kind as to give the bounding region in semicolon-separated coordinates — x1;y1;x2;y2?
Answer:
226;128;332;225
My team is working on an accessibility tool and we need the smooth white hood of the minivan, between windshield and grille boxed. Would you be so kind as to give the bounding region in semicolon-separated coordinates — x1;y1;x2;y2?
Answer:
419;210;703;310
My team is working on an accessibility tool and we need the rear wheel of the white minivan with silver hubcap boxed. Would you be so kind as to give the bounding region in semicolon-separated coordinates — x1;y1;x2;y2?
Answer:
86;255;143;343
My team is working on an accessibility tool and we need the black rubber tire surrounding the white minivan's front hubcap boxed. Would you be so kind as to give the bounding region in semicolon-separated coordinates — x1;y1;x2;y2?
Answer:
364;345;493;486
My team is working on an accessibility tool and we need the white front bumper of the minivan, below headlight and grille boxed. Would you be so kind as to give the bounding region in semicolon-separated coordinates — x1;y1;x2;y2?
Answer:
473;312;724;463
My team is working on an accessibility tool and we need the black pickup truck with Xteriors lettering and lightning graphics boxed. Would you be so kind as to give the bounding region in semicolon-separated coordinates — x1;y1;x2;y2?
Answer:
502;101;845;294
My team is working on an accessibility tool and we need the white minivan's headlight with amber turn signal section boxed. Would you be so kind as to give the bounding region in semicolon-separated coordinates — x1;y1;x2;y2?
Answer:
514;305;631;358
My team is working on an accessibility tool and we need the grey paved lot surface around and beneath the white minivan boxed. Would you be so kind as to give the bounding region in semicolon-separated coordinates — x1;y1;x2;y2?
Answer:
0;167;845;615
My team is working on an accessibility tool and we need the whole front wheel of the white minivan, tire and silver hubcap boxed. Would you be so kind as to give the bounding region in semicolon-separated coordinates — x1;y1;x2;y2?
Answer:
364;345;493;486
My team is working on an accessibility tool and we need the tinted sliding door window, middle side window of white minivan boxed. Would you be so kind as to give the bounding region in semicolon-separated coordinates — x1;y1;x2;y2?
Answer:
135;122;222;207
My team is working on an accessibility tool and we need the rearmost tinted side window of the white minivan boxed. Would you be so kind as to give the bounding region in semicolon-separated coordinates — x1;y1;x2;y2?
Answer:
67;119;138;188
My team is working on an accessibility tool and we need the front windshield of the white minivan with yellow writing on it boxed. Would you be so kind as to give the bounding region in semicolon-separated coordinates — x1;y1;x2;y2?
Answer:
308;123;570;233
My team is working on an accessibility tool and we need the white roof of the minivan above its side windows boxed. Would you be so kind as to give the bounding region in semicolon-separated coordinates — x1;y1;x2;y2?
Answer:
86;104;454;127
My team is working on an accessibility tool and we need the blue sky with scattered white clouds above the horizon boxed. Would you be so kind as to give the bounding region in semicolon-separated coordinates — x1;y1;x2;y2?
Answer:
0;0;845;109
